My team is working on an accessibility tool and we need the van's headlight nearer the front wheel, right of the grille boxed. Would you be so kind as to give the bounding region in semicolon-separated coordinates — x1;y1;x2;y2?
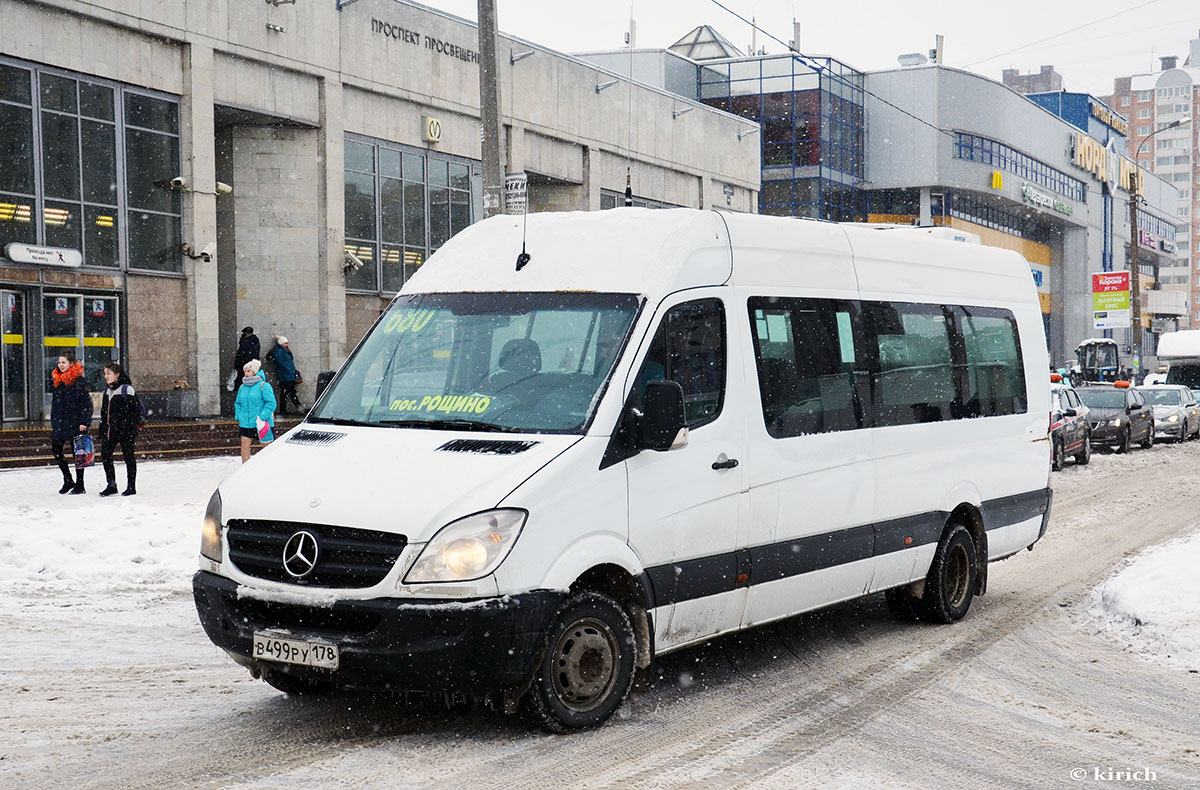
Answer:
404;508;529;585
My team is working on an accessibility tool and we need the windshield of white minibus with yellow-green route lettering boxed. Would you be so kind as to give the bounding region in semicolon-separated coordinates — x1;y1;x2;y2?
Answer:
310;293;640;433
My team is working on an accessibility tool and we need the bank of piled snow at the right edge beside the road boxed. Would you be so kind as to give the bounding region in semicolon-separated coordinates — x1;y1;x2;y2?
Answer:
1091;532;1200;670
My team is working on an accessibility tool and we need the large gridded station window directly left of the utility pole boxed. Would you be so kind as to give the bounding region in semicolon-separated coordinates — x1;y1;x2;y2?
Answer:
346;137;474;293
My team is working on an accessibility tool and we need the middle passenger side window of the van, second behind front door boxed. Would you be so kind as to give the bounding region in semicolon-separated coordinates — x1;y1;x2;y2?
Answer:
866;303;956;426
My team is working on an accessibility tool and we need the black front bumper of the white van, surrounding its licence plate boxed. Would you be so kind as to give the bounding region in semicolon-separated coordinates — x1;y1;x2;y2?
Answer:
192;570;566;694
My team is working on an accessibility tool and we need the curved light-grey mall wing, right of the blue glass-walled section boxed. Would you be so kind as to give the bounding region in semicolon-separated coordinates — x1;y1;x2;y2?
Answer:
866;65;1182;365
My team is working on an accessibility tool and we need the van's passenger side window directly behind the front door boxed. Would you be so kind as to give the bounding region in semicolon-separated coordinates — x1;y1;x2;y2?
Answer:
749;297;865;438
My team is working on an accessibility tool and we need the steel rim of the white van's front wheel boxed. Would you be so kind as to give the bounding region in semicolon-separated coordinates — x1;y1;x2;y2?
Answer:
550;617;620;713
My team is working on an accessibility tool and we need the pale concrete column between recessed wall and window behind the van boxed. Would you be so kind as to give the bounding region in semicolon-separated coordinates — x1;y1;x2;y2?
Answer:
306;79;347;372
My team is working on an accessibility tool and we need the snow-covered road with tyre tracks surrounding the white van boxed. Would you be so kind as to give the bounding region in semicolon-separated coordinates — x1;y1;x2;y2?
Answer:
0;442;1200;790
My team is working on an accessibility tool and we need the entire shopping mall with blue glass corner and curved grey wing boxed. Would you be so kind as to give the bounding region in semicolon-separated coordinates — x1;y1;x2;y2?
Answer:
580;28;1187;365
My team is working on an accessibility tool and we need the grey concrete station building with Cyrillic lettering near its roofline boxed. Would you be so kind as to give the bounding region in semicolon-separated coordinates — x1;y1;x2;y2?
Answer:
0;0;761;420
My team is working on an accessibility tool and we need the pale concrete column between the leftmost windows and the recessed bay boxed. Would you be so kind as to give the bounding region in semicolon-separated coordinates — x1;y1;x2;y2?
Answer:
180;43;221;414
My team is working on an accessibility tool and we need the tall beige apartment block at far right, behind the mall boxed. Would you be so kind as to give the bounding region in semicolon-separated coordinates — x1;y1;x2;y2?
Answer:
1108;36;1200;329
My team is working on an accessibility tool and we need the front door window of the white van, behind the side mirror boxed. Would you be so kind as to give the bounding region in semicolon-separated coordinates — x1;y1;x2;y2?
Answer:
635;299;725;427
